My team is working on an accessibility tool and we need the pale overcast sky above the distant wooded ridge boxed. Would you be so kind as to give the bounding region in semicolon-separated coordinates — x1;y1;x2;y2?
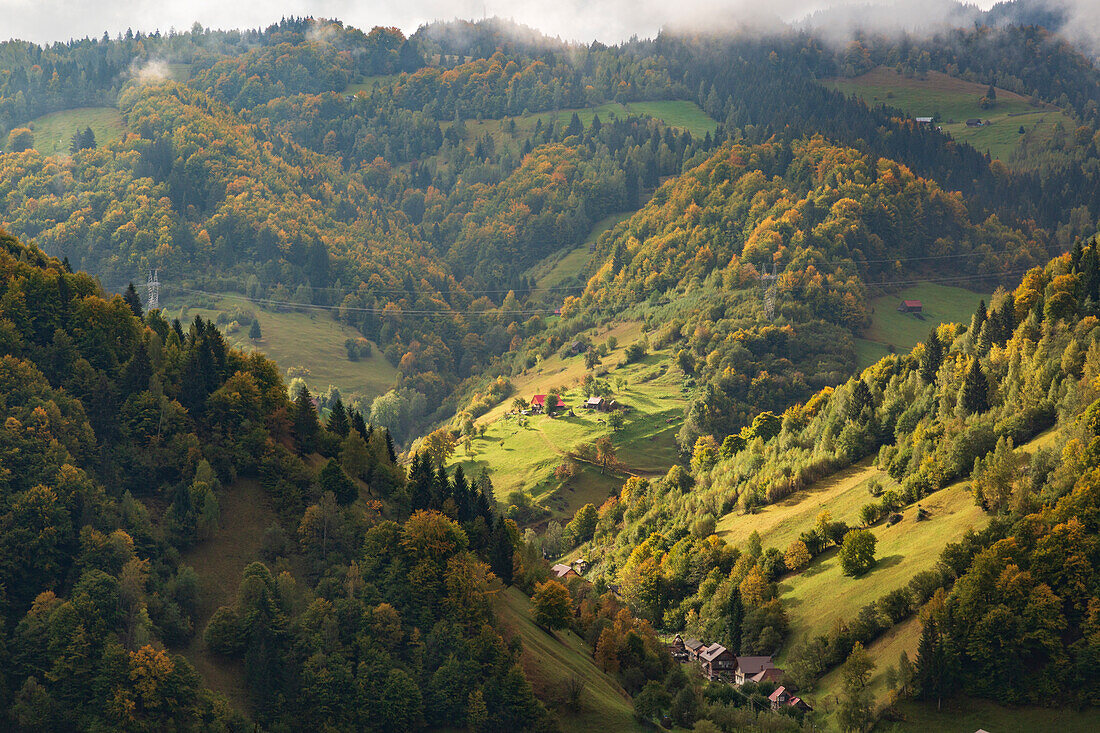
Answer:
0;0;1007;43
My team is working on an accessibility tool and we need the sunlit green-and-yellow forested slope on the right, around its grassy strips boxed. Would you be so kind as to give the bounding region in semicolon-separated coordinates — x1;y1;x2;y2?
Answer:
567;242;1100;726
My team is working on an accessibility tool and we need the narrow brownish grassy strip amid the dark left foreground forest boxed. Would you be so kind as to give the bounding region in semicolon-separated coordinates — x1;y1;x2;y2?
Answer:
183;480;275;712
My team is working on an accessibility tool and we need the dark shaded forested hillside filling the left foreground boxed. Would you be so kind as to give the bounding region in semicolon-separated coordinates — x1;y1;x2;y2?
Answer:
0;236;660;731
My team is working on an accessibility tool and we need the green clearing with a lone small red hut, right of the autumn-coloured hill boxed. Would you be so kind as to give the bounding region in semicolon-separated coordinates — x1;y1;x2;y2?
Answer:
857;283;990;356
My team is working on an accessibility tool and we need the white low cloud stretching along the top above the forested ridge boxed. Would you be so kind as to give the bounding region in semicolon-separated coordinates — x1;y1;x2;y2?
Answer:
0;0;1082;48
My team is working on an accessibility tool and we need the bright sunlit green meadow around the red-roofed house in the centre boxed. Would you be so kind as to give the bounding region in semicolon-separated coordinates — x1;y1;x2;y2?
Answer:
451;322;685;517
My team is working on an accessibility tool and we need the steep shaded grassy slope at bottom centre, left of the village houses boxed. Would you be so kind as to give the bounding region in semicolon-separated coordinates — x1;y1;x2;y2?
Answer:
495;588;644;731
